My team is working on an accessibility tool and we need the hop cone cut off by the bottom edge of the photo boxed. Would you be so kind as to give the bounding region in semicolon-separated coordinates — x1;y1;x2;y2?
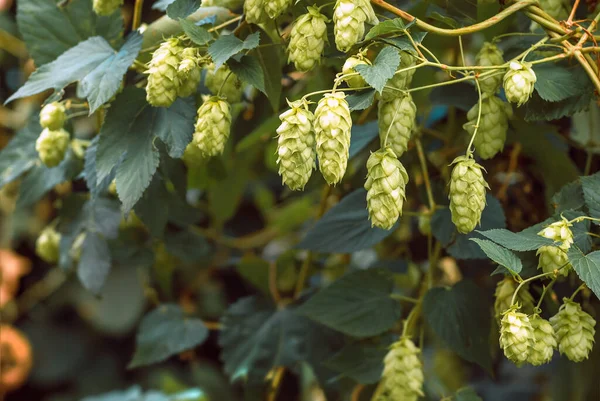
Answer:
372;337;424;401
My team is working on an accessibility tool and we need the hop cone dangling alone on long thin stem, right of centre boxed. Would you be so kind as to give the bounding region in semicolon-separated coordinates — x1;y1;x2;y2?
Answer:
449;156;489;234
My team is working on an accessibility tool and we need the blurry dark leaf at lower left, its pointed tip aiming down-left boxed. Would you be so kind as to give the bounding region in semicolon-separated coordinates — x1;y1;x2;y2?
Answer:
129;304;208;368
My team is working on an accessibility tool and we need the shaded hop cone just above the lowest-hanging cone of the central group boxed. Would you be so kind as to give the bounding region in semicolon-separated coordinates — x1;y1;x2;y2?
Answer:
377;93;417;157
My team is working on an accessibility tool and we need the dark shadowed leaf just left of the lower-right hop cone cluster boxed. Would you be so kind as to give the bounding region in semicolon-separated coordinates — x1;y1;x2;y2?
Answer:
423;280;492;372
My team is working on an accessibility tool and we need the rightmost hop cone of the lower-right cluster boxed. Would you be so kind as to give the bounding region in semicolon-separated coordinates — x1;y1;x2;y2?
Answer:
550;298;596;362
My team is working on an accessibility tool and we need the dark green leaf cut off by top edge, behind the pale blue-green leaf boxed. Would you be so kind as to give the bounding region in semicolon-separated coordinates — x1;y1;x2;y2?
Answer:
17;0;123;67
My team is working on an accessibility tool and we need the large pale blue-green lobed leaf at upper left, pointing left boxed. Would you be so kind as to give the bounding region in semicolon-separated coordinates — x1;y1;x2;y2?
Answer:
7;32;142;113
